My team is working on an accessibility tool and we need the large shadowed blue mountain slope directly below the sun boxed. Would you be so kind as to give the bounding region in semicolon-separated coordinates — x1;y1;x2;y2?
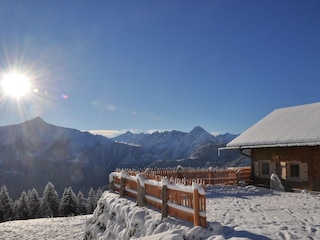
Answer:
0;118;144;198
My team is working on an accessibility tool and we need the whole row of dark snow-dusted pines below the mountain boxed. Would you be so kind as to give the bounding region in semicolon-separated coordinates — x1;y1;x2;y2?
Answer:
0;182;102;222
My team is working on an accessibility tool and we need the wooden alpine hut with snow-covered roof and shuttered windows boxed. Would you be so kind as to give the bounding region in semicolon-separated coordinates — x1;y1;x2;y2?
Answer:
225;102;320;191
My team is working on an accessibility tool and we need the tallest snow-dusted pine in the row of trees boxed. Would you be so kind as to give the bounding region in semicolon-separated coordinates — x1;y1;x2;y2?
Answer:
41;182;59;217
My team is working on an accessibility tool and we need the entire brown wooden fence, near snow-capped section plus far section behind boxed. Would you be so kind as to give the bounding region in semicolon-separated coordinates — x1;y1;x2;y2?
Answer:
109;167;251;227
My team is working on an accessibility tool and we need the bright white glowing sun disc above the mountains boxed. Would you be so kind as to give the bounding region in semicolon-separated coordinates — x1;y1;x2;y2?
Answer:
1;72;31;98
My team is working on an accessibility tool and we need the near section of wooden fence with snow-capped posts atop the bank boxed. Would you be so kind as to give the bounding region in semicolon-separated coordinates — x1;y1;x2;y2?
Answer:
109;171;206;227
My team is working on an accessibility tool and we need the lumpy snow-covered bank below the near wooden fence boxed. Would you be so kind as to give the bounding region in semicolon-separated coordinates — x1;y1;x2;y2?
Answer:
85;192;222;240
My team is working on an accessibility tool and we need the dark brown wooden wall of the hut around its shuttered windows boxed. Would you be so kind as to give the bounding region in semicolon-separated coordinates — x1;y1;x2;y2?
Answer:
251;146;320;191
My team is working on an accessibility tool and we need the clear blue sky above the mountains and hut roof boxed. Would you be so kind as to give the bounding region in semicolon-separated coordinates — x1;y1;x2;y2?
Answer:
0;0;320;134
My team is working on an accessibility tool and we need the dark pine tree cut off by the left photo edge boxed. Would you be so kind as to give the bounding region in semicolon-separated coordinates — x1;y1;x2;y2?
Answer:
0;185;13;222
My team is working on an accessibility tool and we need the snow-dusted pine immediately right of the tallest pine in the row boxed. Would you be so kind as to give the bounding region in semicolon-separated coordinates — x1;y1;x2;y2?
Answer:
60;187;78;216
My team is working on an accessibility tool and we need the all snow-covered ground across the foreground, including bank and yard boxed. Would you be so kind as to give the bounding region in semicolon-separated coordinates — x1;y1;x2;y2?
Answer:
0;186;320;240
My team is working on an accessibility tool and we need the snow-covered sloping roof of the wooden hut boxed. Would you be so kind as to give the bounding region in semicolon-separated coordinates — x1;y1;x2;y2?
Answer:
226;102;320;149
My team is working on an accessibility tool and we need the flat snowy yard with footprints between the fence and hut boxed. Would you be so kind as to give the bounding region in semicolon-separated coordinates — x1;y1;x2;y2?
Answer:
207;186;320;239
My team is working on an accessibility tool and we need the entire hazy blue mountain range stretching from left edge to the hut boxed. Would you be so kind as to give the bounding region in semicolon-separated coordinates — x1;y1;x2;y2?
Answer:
0;117;248;198
